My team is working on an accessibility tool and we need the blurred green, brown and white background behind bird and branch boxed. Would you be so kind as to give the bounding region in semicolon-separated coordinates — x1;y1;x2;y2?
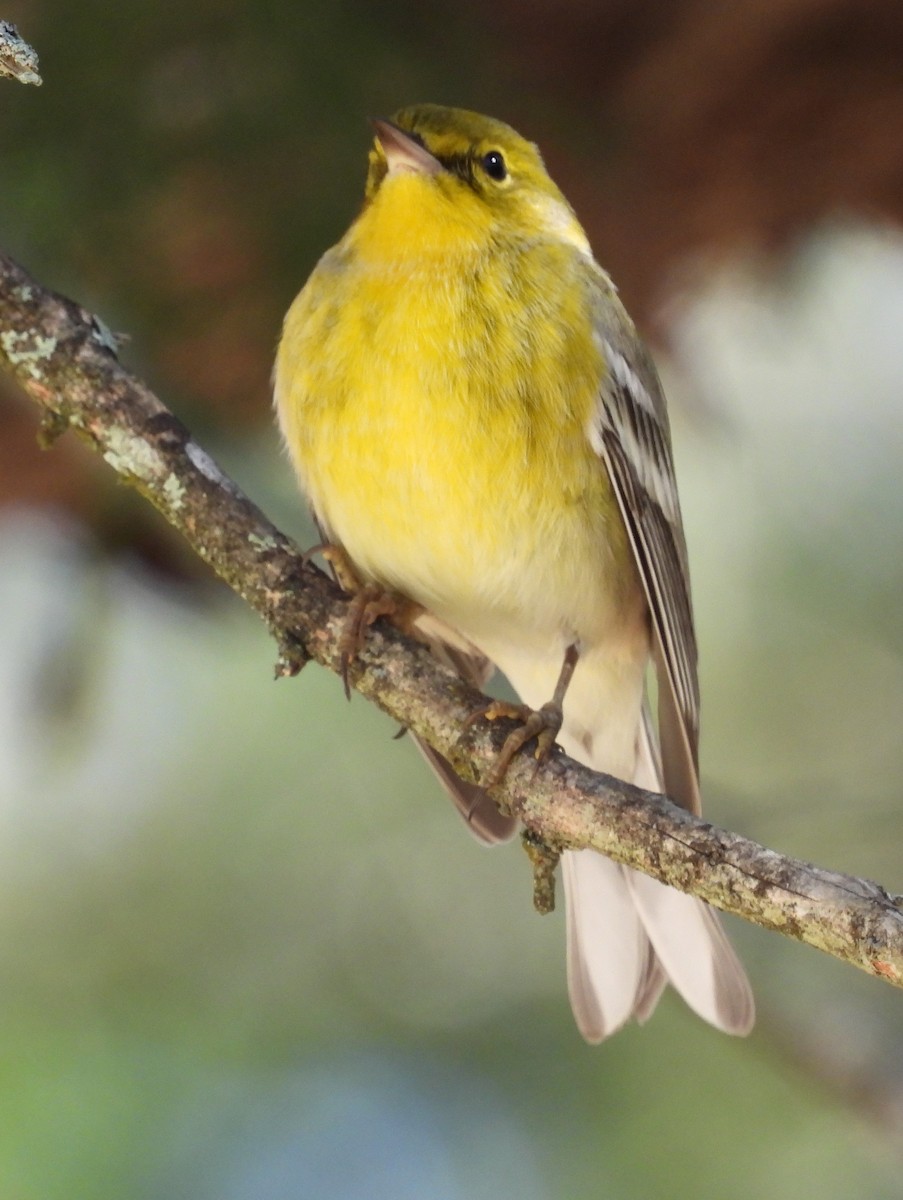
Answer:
0;0;903;1200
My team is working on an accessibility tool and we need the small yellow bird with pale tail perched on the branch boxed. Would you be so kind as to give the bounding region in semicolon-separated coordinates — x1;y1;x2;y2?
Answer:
275;104;754;1042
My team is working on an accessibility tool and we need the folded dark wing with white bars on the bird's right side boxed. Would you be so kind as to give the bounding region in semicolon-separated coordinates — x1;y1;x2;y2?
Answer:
590;270;700;812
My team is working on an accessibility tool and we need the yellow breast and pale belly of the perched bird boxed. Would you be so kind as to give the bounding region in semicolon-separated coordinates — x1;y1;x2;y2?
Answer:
276;179;636;641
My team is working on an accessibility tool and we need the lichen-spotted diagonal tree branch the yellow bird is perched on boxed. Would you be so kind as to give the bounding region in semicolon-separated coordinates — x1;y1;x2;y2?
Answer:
0;248;903;986
